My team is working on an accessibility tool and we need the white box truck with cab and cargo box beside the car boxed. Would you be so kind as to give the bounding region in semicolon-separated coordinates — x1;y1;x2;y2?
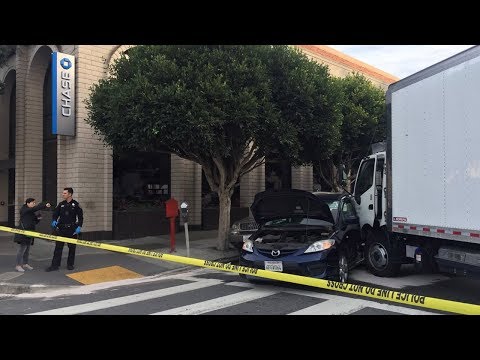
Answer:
353;46;480;276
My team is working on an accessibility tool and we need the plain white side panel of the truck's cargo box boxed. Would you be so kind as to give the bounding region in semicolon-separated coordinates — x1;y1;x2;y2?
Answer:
391;54;480;230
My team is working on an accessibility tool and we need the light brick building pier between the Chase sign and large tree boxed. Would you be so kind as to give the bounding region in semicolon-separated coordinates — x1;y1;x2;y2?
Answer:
57;45;113;240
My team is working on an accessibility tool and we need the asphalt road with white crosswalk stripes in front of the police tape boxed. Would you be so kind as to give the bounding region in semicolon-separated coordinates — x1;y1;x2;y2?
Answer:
0;269;458;315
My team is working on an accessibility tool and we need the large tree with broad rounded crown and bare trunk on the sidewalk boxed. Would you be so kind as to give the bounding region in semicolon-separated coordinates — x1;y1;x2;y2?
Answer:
86;45;342;250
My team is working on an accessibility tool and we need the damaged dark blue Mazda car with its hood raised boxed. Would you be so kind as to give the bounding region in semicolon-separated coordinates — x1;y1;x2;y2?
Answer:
239;189;363;282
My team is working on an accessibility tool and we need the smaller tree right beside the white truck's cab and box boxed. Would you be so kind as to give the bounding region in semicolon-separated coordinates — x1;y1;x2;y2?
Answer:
315;74;386;191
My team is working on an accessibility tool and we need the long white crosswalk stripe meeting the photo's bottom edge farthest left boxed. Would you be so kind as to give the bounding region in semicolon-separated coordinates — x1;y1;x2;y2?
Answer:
27;279;223;315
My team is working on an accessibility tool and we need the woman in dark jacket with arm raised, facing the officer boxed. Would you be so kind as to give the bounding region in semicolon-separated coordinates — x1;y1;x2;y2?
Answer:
14;198;50;272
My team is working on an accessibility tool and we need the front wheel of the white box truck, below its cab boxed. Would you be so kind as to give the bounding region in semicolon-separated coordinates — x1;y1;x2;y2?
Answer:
365;231;401;277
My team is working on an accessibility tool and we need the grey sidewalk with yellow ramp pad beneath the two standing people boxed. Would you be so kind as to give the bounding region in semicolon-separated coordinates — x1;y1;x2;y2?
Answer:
0;230;239;294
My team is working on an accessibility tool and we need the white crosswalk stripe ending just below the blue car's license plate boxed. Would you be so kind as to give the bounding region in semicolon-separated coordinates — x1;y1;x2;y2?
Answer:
151;289;278;315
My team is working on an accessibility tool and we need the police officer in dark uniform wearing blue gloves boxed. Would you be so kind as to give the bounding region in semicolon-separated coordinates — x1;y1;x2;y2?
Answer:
45;187;83;271
